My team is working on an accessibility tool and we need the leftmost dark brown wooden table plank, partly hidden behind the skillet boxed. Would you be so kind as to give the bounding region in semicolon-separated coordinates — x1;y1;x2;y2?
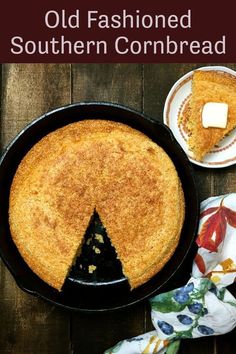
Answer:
0;65;70;354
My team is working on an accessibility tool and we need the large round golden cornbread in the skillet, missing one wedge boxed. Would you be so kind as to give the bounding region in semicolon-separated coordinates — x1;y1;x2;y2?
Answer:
9;120;185;290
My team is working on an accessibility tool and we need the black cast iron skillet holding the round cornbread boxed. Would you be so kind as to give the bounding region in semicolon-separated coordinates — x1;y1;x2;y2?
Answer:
0;102;198;312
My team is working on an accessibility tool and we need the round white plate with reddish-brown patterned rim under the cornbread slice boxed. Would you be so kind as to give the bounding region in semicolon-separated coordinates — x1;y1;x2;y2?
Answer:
164;66;236;168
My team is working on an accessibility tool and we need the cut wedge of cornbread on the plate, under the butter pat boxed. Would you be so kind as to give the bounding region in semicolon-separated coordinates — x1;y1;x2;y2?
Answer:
187;70;236;161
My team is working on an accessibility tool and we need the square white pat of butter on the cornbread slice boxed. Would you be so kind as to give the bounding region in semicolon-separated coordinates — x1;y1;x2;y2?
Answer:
202;102;228;129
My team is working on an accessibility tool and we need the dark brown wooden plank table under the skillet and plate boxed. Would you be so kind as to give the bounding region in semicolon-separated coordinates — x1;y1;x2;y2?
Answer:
0;64;236;354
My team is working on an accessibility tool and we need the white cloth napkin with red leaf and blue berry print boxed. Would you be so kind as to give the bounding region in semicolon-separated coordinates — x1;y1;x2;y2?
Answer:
104;193;236;354
